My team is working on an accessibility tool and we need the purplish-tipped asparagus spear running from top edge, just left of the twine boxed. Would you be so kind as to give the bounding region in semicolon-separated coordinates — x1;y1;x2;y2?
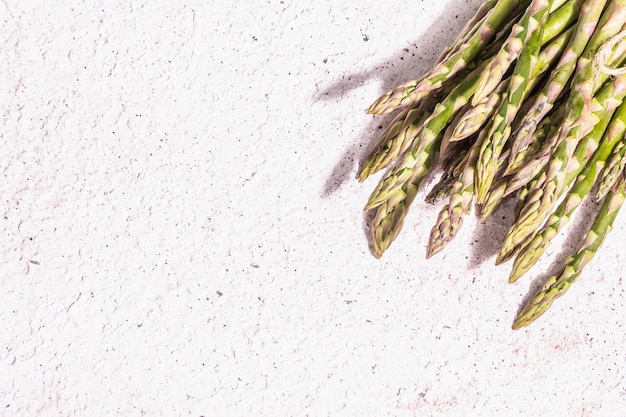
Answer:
510;0;612;171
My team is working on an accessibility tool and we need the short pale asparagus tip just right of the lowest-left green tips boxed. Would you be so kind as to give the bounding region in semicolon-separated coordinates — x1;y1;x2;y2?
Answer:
426;137;481;258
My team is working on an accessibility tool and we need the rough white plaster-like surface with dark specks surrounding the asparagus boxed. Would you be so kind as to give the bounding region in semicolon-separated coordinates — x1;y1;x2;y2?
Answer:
0;0;626;417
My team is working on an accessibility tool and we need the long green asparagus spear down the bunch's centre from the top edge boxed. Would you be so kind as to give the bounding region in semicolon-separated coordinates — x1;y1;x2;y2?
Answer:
474;0;553;204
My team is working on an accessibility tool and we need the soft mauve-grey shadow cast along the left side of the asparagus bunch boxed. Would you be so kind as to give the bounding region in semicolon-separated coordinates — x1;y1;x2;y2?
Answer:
315;0;481;198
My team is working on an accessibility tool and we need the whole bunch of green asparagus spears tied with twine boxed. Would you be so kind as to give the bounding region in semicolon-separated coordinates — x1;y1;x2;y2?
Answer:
359;0;626;328
